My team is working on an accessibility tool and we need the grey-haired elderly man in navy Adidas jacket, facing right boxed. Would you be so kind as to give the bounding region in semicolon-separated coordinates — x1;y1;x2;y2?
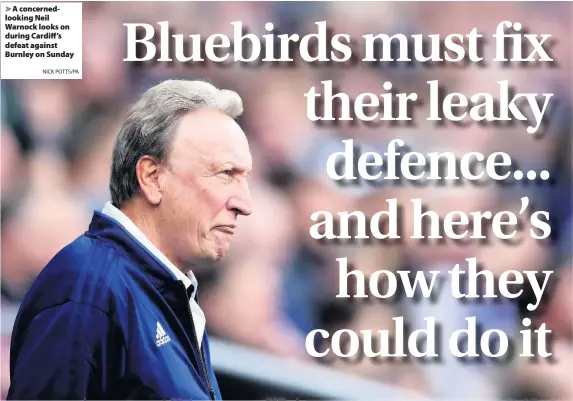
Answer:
8;81;252;399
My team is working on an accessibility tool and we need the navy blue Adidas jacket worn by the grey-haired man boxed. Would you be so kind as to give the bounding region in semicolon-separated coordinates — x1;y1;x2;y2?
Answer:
7;212;221;400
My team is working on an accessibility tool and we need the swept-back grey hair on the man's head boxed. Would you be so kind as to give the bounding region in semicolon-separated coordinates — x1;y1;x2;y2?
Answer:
109;80;243;207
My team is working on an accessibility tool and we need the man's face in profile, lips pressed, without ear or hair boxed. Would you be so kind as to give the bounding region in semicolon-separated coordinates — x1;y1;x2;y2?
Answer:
161;109;252;263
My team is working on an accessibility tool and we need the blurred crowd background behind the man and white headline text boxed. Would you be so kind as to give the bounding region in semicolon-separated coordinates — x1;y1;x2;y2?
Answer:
1;2;573;399
